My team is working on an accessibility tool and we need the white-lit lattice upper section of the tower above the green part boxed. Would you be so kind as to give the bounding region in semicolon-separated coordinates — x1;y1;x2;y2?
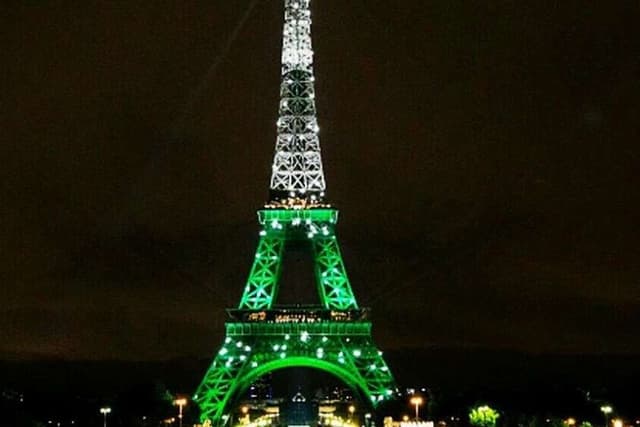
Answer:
270;0;326;207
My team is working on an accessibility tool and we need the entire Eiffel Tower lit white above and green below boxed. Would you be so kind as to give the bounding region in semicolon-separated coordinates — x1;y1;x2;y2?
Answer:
193;0;396;425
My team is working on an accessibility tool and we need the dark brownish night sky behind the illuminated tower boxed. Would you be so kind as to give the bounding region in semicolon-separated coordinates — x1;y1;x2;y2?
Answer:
0;0;640;359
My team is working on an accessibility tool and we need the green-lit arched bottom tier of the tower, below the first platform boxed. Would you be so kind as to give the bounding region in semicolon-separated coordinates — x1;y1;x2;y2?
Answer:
194;322;396;424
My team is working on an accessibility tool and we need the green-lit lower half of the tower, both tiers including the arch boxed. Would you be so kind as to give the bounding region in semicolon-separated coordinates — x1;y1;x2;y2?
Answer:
194;207;395;425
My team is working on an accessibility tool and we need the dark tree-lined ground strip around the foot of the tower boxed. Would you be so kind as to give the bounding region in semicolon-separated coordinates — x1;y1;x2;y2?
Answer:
0;350;640;427
